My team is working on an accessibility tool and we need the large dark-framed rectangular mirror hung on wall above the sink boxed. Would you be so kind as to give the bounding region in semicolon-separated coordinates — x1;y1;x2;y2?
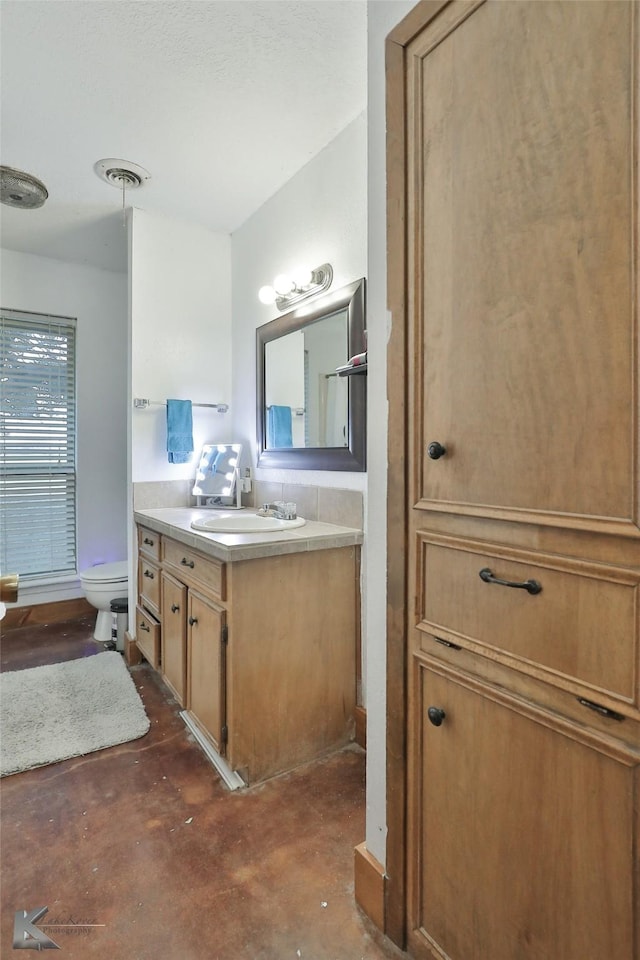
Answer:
256;279;366;472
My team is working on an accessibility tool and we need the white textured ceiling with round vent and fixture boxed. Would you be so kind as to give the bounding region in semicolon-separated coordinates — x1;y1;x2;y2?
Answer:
0;0;366;270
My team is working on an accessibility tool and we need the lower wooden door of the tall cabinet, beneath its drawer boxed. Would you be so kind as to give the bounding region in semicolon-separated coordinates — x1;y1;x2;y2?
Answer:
412;666;640;960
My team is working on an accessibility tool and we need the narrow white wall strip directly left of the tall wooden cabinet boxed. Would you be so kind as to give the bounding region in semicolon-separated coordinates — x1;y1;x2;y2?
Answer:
363;0;415;864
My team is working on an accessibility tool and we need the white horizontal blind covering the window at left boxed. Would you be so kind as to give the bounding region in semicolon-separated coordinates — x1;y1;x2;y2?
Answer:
0;310;76;581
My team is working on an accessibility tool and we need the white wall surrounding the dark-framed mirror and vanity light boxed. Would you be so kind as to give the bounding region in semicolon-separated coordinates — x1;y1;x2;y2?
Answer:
231;114;367;492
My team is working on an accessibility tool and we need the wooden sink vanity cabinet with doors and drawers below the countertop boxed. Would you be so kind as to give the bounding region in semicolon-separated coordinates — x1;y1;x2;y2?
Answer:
136;531;360;783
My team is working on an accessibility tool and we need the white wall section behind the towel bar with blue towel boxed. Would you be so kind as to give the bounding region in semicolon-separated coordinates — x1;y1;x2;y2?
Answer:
130;210;236;483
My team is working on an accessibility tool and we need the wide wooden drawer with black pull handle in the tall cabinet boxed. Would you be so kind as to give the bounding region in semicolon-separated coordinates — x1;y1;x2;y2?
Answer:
418;535;640;703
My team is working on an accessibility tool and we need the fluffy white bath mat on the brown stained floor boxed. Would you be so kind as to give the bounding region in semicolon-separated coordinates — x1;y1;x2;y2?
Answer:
0;651;150;777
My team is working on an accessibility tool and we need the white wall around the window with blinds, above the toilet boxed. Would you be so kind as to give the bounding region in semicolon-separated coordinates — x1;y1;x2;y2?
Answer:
0;248;127;606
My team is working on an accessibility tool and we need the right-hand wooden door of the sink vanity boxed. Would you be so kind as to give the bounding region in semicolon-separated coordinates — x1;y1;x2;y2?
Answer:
187;590;226;756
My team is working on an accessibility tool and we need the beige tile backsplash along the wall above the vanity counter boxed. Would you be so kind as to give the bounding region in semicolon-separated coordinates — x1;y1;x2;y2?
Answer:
133;480;364;530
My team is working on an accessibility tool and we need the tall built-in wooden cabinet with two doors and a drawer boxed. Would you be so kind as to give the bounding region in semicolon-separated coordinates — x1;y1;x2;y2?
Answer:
388;0;640;960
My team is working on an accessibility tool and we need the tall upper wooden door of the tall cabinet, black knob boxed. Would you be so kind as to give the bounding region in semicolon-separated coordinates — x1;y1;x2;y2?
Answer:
408;0;638;534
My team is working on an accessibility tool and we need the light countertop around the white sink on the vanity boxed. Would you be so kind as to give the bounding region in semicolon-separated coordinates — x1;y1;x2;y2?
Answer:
134;507;363;563
